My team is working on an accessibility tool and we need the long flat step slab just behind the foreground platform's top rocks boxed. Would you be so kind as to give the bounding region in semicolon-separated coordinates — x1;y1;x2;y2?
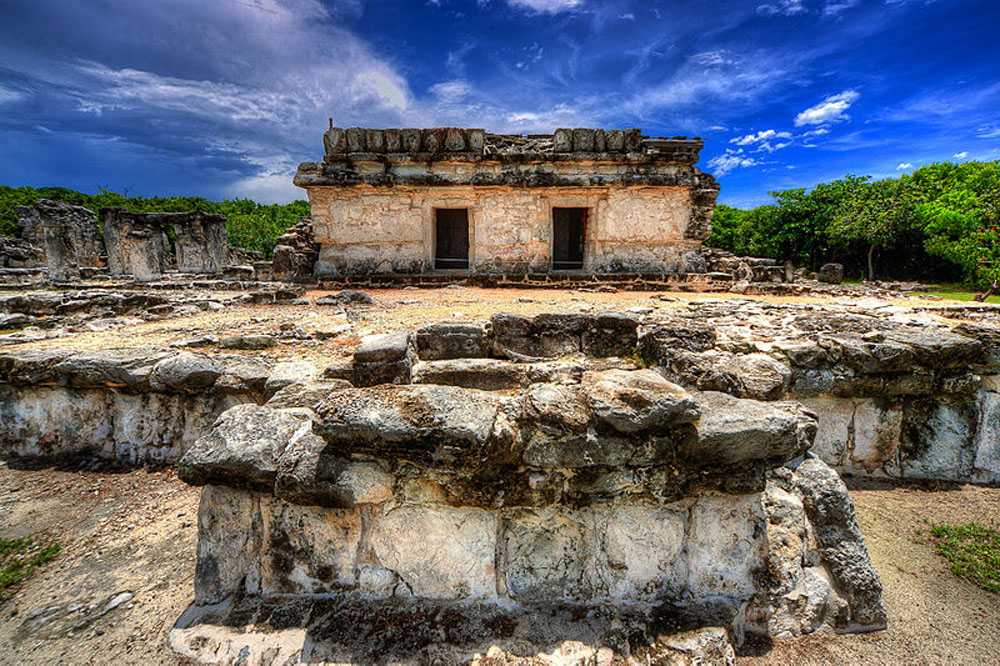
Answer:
412;358;584;391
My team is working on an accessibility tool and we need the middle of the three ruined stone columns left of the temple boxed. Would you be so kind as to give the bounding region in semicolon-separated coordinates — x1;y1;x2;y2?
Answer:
100;208;167;282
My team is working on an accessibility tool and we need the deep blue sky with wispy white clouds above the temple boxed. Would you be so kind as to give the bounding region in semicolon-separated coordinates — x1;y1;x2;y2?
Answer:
0;0;1000;206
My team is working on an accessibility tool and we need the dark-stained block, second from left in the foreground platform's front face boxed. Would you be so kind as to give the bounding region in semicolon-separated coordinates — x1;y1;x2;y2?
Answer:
260;495;361;594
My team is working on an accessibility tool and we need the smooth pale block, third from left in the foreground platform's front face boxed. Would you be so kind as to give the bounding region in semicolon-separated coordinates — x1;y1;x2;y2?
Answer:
371;506;497;601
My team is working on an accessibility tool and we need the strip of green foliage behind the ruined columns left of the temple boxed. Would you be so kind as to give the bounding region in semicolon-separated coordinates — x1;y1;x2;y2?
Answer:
0;185;309;257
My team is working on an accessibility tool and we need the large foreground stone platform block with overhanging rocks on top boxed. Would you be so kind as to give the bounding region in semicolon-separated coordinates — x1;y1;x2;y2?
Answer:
171;369;886;663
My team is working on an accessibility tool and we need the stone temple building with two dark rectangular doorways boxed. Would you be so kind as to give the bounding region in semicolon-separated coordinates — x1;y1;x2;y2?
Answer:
294;127;719;276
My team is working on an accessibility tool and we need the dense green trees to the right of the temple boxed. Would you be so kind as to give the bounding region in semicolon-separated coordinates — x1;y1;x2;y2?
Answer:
708;161;1000;287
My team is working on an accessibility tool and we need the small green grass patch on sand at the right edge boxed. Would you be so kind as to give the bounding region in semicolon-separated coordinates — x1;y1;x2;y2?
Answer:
931;522;1000;593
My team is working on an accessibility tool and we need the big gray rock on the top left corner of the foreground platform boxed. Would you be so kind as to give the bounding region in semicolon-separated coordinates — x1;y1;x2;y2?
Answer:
177;405;312;492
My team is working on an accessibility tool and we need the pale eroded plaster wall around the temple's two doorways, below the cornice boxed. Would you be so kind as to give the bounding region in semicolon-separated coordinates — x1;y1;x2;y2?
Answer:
308;179;701;275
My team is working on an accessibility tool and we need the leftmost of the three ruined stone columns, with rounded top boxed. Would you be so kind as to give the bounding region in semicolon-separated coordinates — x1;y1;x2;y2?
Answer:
35;199;100;281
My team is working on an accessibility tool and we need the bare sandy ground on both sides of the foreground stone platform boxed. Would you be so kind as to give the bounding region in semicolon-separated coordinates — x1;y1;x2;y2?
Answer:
0;466;1000;666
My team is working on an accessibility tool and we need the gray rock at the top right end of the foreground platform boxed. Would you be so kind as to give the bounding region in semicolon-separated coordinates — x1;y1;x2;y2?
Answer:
679;391;817;465
